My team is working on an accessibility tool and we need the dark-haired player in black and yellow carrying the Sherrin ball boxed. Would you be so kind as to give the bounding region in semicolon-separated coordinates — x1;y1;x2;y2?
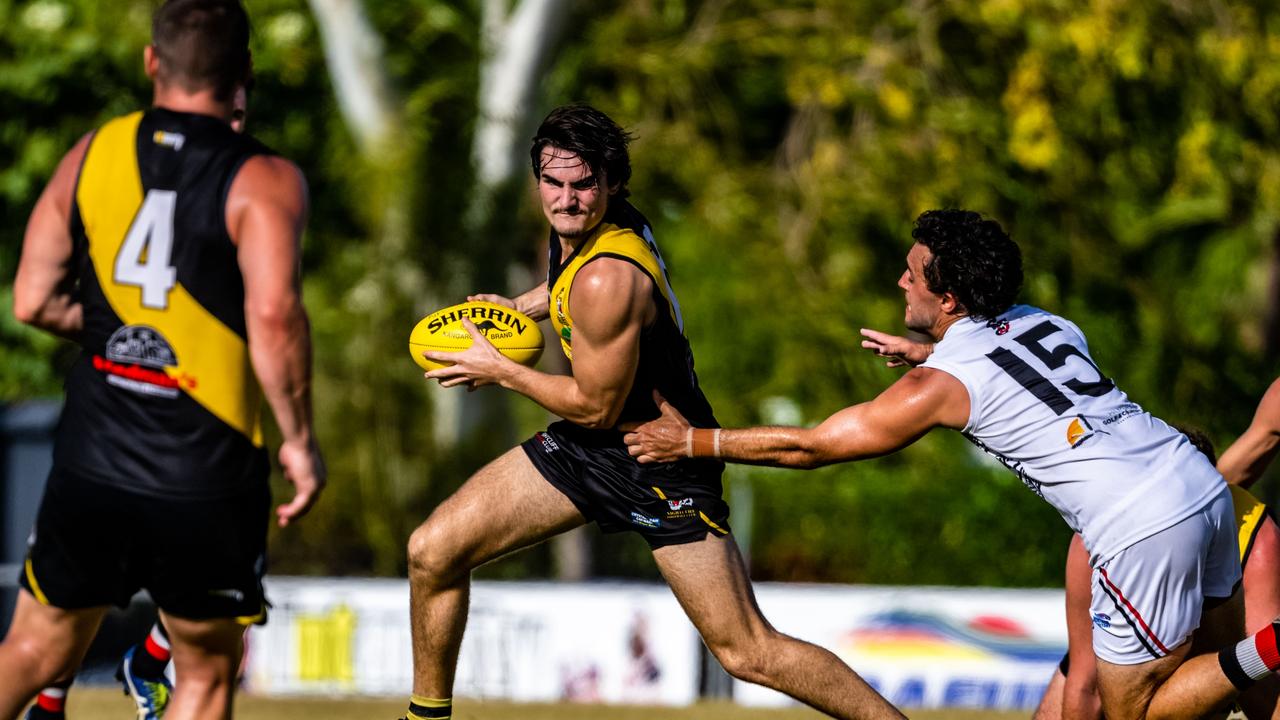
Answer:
408;105;901;720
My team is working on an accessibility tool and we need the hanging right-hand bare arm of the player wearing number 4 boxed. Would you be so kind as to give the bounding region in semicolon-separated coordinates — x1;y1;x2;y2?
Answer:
227;155;325;527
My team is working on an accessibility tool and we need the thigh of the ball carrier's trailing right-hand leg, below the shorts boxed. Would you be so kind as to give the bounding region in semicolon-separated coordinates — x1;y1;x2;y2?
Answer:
653;532;773;650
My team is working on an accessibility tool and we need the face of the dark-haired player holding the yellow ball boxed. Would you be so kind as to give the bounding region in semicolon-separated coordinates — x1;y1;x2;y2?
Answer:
538;145;609;240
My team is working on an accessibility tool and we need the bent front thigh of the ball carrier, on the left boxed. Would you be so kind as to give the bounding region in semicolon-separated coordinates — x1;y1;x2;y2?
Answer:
410;447;586;568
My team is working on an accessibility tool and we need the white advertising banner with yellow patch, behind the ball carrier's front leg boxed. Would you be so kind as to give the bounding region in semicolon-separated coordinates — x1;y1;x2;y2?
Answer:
246;578;700;705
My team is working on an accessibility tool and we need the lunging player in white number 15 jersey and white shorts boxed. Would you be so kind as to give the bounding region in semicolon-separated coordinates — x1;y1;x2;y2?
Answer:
626;210;1280;720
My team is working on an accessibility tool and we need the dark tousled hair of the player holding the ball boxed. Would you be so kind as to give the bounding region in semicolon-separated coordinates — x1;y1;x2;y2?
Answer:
529;105;631;197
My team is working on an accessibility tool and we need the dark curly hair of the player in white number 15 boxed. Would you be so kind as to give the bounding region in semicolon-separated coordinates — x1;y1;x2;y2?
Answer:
911;210;1023;320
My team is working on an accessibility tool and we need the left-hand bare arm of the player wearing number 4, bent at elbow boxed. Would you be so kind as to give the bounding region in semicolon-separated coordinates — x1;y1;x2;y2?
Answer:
13;135;92;338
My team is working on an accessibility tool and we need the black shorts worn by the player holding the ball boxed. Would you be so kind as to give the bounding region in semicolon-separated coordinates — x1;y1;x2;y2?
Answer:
521;421;730;548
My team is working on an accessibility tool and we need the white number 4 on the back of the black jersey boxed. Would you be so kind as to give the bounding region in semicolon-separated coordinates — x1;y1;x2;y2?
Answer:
111;190;178;310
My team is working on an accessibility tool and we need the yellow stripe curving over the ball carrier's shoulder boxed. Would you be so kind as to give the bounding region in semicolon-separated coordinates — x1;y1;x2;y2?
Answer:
550;223;684;360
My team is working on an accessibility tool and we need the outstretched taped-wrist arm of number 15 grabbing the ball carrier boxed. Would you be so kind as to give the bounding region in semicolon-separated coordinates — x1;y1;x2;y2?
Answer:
622;368;969;468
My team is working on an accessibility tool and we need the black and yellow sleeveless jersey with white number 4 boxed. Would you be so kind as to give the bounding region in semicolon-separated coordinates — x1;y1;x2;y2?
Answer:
55;109;270;498
